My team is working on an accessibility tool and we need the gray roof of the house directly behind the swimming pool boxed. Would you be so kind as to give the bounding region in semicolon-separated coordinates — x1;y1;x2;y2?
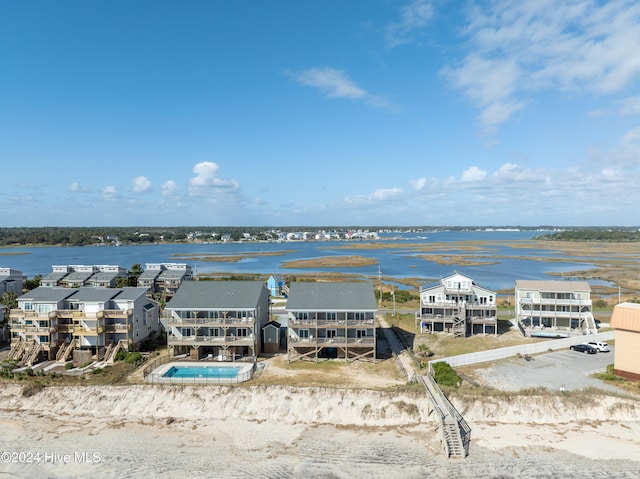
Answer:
166;281;266;310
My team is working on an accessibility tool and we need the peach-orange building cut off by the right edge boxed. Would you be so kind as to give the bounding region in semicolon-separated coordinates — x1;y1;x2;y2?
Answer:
610;303;640;381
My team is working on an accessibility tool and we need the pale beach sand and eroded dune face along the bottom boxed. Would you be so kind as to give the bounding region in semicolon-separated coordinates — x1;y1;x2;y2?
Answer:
0;384;640;479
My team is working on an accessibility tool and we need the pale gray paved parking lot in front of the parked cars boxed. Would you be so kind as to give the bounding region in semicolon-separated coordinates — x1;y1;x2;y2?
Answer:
476;348;618;391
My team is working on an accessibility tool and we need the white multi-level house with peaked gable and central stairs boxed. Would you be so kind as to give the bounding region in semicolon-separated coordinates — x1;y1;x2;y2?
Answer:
416;272;498;337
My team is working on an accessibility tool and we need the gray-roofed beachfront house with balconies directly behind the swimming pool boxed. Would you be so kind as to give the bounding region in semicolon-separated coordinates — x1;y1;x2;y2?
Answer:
165;281;269;361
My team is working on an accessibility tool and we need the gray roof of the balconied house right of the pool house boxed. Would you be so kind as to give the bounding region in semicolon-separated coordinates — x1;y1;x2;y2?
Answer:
286;282;378;311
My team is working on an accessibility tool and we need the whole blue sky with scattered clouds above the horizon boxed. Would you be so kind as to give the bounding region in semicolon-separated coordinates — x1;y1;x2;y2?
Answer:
0;0;640;226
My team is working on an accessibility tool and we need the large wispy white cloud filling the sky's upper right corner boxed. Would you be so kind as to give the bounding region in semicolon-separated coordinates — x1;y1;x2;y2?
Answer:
442;0;640;129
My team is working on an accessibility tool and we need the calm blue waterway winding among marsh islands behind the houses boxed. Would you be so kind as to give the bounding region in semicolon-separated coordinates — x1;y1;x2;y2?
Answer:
0;231;601;290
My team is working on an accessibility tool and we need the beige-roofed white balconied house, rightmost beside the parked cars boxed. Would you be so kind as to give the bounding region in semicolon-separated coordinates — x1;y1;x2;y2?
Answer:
515;280;597;338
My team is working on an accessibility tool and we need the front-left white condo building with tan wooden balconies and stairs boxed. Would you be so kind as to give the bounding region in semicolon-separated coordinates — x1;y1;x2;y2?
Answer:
9;286;159;365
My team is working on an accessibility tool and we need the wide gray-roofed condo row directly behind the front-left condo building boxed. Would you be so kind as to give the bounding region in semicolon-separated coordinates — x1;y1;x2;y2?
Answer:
40;265;127;288
